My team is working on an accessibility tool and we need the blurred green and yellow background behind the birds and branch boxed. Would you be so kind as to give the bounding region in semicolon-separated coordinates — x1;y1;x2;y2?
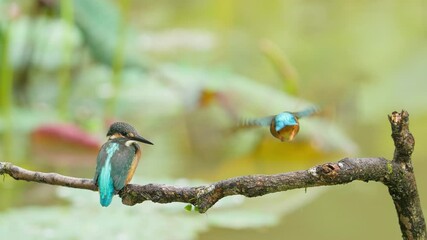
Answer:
0;0;427;240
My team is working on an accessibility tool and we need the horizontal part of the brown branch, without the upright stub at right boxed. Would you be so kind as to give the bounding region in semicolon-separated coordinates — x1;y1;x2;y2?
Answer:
0;158;392;210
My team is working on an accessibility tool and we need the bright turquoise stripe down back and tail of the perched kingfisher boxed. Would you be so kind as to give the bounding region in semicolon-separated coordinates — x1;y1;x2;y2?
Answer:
98;143;119;207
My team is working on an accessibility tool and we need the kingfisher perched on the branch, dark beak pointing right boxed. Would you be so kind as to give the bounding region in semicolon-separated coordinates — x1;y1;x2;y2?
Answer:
93;122;153;207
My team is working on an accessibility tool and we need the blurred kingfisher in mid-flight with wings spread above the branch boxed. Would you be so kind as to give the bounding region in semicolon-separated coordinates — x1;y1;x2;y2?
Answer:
242;107;318;142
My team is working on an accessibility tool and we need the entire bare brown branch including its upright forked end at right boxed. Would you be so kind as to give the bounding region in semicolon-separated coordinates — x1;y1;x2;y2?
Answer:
0;111;426;239
